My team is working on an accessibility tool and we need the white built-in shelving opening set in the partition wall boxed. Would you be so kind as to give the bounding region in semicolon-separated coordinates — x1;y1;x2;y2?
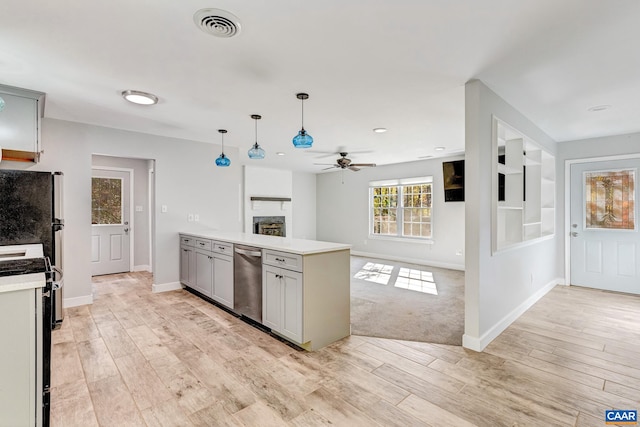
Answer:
493;117;555;252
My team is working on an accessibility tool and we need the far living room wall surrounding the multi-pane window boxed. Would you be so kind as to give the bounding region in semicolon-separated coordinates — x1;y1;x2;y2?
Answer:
316;157;465;270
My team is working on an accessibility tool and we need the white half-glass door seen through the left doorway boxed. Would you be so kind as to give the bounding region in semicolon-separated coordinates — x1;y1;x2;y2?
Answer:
91;168;131;276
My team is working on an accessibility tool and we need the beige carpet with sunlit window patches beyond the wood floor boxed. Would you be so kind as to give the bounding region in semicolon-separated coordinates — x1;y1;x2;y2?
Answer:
351;256;464;345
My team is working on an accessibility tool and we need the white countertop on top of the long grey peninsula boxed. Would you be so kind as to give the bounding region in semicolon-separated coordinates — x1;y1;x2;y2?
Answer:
180;230;351;255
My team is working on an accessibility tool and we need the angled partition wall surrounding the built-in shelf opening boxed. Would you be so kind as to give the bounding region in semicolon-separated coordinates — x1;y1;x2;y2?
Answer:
463;80;562;351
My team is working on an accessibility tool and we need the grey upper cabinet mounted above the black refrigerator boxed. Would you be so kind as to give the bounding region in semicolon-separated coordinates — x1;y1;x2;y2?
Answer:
0;85;45;162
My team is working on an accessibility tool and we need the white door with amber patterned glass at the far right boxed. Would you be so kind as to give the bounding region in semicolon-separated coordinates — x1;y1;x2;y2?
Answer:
569;158;640;294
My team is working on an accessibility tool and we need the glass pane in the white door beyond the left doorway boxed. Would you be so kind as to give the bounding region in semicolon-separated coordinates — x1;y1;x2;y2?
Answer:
91;178;122;224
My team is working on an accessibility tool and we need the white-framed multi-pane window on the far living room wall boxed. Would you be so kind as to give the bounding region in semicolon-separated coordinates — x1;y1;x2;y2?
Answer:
369;176;433;239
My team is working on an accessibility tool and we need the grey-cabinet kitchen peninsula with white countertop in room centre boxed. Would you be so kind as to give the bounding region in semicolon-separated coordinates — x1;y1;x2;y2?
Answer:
180;230;351;350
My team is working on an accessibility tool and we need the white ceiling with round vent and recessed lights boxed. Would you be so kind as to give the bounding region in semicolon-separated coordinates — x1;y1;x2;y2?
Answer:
0;0;640;172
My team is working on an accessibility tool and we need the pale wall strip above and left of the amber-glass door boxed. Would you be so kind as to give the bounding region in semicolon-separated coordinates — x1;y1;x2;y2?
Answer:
556;133;640;276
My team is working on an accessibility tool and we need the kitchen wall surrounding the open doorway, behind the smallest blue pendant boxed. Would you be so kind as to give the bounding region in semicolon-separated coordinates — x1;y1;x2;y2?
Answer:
2;119;242;306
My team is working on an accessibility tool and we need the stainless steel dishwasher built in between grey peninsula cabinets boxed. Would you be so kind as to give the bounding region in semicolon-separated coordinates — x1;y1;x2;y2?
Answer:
233;245;262;323
